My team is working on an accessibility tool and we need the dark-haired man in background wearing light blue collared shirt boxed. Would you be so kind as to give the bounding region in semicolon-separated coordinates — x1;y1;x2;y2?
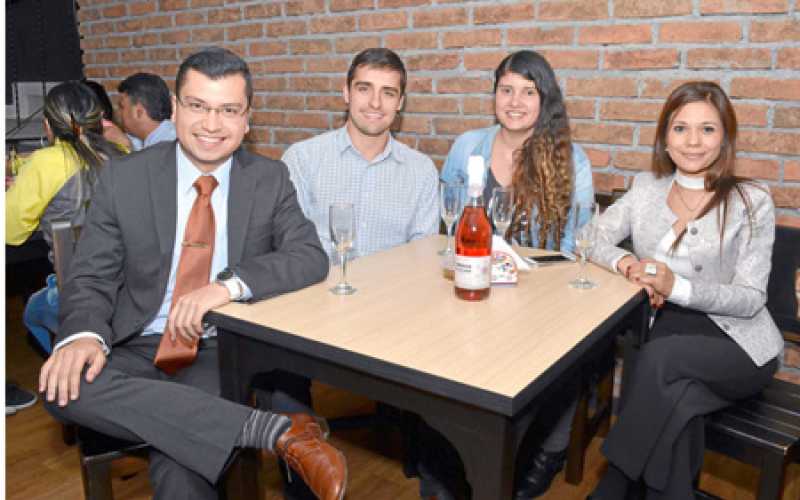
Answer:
117;73;175;151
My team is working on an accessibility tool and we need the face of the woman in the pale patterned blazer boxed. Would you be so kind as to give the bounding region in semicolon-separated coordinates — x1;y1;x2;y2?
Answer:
666;101;723;176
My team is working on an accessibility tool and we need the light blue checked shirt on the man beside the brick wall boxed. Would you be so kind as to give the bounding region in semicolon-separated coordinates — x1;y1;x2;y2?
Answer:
283;127;439;257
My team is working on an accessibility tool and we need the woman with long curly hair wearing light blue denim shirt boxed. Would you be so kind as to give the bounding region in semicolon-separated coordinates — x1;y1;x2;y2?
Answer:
441;50;594;252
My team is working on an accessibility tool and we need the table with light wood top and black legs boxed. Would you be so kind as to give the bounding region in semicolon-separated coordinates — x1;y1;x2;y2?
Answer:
209;236;646;500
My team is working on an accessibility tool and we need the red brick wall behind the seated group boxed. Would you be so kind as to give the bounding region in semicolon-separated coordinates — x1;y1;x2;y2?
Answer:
78;0;800;226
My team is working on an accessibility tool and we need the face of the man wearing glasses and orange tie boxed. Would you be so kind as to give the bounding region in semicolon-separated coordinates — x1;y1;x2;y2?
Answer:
172;69;250;172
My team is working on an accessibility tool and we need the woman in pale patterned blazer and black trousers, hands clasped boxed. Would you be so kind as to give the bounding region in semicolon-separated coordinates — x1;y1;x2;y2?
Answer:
584;82;783;500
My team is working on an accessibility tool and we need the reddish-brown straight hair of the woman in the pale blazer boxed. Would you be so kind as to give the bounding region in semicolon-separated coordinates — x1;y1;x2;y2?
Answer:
651;82;755;249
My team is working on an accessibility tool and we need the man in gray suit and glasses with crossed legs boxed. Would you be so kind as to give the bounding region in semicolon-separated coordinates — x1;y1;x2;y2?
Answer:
39;48;346;500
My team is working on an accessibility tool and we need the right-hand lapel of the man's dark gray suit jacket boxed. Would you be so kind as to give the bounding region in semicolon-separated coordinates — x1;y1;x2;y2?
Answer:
228;150;256;266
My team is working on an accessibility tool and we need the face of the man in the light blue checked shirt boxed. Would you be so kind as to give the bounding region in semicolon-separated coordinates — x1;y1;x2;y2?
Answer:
343;65;403;137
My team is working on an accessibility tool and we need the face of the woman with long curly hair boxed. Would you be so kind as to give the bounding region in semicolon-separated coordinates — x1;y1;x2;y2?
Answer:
494;71;541;132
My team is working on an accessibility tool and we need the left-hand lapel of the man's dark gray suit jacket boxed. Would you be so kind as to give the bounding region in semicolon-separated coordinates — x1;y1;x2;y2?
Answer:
148;143;178;264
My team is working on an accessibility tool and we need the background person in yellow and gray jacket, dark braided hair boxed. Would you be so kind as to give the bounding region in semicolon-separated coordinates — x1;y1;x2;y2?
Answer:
6;82;121;354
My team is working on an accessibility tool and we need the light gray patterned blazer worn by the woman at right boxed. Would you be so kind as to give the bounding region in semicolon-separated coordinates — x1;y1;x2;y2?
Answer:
592;172;783;366
